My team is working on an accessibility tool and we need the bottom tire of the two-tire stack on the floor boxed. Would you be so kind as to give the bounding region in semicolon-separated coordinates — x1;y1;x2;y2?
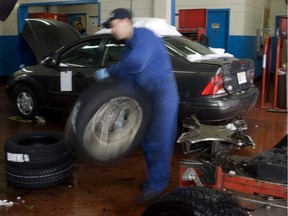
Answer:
6;160;73;189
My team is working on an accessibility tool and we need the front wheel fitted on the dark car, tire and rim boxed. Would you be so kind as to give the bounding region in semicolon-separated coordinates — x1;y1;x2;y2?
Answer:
13;86;39;120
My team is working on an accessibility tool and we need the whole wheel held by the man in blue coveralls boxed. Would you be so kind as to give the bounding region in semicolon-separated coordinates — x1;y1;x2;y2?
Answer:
66;79;151;162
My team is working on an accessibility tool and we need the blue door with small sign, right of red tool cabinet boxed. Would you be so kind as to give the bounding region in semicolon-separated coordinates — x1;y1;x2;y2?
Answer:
206;9;229;50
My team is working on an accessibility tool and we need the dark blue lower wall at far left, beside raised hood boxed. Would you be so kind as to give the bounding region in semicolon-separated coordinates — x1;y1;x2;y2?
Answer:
0;36;20;76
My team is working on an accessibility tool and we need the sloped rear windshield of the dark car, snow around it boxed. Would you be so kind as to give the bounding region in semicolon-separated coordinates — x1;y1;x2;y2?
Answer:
164;37;213;58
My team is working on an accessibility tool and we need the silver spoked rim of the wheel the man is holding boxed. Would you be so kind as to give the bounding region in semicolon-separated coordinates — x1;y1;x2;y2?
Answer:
83;97;143;161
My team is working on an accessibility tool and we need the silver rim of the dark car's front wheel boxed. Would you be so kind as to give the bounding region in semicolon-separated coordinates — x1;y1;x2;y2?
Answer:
17;92;34;115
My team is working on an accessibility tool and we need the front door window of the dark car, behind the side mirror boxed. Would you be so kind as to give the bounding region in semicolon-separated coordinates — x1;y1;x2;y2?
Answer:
60;39;101;67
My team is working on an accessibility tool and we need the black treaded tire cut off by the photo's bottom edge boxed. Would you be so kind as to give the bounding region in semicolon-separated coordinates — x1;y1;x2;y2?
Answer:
142;187;249;216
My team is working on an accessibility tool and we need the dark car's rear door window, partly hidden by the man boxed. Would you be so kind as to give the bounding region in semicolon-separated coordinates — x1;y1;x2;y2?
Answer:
102;38;125;67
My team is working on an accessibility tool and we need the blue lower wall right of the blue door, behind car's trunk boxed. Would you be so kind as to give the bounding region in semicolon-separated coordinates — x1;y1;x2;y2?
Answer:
227;35;262;77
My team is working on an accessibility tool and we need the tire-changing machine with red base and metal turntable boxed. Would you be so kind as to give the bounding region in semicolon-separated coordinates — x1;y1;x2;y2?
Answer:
177;116;288;213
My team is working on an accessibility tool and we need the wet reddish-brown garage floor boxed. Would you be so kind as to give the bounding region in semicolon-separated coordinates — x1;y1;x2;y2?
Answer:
0;79;287;216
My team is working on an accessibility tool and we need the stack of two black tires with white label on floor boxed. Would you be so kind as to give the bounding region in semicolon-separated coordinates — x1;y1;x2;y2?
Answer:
4;131;73;189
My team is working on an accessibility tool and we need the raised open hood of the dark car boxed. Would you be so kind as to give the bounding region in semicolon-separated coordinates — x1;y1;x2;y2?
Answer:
22;19;81;63
